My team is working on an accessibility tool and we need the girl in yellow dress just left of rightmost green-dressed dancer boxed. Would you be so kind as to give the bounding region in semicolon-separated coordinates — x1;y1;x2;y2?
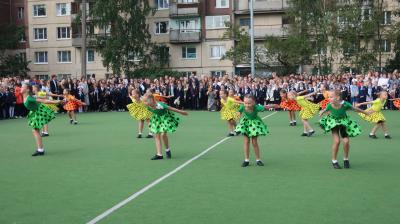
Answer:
288;90;319;137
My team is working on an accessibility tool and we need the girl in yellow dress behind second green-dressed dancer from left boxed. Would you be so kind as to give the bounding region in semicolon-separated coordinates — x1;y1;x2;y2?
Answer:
126;89;153;138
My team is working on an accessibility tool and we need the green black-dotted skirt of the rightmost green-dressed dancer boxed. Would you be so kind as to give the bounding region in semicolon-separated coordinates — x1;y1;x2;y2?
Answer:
316;114;362;137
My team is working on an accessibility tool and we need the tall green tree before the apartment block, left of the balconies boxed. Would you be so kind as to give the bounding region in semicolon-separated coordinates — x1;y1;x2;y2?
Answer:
72;0;173;76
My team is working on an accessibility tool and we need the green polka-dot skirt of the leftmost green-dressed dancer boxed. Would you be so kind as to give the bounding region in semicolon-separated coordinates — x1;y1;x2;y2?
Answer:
27;104;56;129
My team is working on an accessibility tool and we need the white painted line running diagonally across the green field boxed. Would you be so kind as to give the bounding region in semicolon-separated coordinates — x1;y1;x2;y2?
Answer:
87;111;278;224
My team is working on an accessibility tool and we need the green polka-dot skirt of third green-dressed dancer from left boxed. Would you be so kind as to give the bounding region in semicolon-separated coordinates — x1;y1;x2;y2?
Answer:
234;116;268;137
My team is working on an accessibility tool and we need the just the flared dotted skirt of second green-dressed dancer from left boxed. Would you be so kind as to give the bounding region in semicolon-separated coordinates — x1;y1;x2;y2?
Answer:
149;110;182;133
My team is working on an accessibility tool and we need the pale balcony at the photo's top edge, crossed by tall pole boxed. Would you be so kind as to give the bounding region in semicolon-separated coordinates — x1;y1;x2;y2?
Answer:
235;0;290;14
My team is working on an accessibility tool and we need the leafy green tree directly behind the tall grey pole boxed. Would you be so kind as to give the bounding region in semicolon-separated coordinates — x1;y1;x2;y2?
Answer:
220;22;309;75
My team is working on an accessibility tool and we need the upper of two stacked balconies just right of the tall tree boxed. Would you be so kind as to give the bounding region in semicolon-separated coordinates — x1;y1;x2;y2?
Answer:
169;0;201;17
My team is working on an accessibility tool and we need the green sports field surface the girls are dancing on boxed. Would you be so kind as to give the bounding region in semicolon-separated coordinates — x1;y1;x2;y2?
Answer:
0;111;400;224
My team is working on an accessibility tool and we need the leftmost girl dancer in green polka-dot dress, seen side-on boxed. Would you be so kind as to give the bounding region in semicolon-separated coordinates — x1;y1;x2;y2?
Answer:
21;84;62;156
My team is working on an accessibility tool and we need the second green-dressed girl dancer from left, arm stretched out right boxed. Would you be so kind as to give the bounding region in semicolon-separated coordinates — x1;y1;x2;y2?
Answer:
143;93;189;160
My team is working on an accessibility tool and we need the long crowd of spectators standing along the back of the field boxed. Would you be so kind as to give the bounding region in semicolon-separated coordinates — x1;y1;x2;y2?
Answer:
0;70;400;119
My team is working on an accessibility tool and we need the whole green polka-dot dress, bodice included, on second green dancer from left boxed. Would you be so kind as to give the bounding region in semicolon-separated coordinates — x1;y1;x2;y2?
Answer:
147;102;182;133
